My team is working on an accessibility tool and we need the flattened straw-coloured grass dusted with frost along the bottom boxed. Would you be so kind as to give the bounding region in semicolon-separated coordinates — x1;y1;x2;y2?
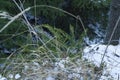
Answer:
1;57;98;80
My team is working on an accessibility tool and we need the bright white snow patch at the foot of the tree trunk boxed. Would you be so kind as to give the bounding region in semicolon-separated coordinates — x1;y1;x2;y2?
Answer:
83;44;120;80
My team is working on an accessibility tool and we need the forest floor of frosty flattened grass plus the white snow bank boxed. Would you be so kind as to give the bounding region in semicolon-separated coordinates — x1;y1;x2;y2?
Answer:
0;44;120;80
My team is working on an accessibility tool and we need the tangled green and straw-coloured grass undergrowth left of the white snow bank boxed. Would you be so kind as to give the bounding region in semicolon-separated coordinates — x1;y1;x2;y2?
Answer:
0;2;102;80
